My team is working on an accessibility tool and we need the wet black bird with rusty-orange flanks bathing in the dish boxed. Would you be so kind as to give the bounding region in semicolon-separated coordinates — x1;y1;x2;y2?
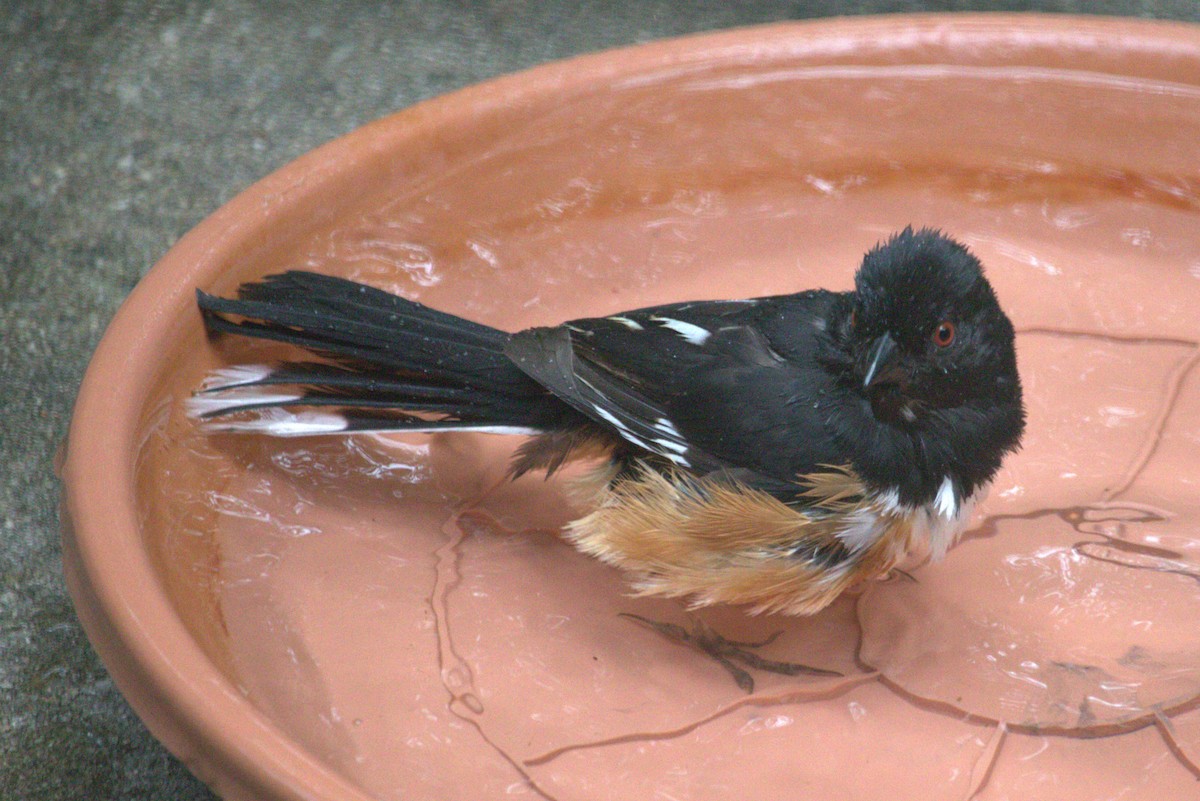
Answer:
187;225;1025;615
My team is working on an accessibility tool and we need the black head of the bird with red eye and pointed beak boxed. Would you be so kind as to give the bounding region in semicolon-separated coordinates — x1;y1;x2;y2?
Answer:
842;228;1025;494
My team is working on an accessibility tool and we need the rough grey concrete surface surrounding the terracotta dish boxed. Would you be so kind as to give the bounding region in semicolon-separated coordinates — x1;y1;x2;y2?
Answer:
0;0;1200;801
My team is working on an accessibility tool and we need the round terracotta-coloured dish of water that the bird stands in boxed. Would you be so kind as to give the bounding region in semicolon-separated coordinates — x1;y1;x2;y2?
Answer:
65;17;1200;801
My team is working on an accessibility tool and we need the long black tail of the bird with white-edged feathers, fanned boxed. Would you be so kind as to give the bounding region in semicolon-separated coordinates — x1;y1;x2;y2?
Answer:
188;271;575;436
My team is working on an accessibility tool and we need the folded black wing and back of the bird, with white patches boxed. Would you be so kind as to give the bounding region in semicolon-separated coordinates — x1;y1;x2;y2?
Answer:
505;291;841;494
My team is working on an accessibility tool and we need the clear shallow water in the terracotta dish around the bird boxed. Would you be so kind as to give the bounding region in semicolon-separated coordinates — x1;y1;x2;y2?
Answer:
136;64;1200;800
